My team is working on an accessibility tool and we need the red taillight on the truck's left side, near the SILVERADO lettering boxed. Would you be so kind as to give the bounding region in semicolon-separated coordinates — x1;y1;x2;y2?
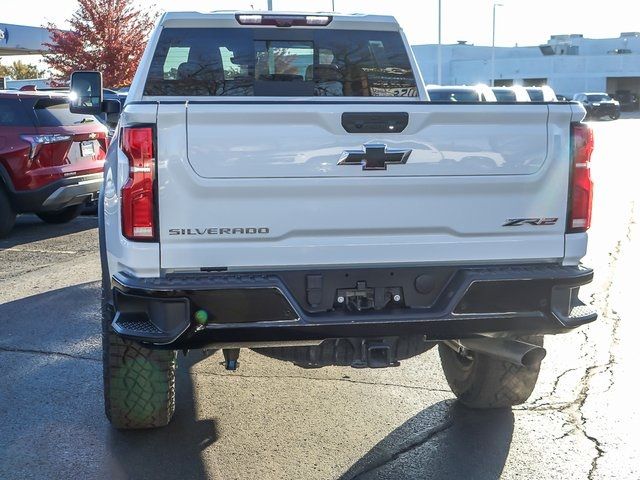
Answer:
121;127;156;242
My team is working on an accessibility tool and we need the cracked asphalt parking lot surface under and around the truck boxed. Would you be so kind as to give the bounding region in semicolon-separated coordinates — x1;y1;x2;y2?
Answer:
0;119;640;480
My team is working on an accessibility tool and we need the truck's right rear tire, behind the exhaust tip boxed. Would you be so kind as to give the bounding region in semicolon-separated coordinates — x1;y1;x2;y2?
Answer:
438;335;543;409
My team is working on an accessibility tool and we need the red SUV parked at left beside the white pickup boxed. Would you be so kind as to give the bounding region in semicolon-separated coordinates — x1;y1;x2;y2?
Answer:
0;91;108;238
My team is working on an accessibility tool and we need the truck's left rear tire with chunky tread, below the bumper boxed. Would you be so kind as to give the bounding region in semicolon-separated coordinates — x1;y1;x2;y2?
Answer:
102;294;176;430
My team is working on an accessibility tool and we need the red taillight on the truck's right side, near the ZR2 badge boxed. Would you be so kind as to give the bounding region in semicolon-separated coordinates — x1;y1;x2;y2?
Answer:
567;123;594;233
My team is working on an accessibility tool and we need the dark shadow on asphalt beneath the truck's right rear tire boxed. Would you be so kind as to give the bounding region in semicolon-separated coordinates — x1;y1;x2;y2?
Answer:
340;400;514;480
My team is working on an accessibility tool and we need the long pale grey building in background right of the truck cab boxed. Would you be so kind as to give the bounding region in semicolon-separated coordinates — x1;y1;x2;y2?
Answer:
413;32;640;96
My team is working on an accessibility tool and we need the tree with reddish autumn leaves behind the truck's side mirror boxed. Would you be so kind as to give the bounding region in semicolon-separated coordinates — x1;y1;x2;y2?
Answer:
44;0;157;88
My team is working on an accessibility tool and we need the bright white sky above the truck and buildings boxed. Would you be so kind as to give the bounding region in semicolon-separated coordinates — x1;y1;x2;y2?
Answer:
0;0;640;63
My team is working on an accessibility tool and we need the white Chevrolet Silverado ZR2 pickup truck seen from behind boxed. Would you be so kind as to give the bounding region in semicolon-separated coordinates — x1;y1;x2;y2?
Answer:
71;12;596;428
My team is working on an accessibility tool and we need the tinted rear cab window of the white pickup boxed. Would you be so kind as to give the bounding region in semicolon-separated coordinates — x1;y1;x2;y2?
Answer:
144;28;418;97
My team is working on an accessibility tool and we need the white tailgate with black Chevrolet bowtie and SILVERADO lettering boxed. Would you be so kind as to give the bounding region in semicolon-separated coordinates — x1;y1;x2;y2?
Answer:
157;101;571;270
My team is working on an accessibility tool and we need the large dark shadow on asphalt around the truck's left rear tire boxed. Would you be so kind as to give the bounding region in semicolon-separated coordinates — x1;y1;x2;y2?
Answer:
0;282;218;480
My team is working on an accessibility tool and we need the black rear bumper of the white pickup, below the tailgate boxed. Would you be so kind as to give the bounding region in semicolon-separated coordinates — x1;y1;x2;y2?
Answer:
112;265;597;349
